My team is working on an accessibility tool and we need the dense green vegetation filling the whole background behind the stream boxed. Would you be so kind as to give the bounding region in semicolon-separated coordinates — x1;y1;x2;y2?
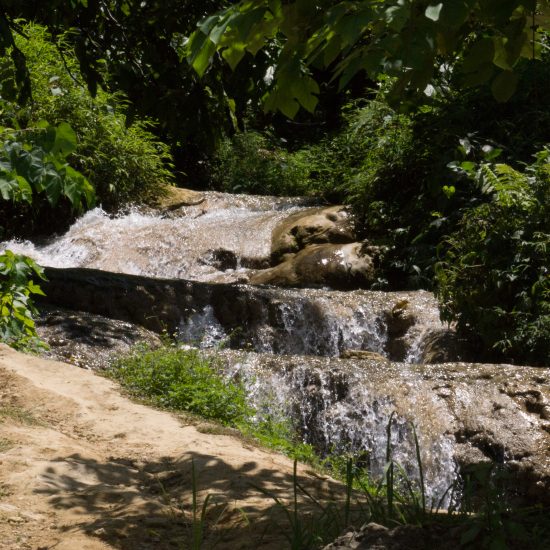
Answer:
0;4;550;364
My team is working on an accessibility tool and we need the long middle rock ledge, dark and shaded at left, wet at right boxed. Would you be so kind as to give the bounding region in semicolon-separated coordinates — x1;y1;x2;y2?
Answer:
37;268;441;359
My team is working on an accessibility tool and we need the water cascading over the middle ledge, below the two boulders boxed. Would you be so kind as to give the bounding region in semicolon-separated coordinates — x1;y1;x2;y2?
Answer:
178;287;441;362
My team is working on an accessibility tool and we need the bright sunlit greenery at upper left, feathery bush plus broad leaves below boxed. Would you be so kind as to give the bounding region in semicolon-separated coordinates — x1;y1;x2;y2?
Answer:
0;25;173;236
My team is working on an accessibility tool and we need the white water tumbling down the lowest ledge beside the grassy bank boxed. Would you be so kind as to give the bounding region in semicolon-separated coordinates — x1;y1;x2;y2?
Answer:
222;354;456;505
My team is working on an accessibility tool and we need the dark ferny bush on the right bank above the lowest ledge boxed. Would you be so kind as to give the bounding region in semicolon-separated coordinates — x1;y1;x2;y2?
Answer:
437;147;550;365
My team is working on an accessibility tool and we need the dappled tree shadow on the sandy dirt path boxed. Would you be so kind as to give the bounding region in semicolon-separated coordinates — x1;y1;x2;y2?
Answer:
35;452;345;550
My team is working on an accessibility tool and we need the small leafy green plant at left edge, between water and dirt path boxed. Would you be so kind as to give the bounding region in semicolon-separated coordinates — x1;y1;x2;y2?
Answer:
0;250;45;349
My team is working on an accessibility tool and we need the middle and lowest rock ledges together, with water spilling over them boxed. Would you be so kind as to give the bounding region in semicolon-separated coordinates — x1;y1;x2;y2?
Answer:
36;269;550;504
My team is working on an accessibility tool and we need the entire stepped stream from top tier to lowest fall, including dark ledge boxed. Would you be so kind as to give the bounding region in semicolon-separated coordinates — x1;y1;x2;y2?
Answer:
0;192;548;508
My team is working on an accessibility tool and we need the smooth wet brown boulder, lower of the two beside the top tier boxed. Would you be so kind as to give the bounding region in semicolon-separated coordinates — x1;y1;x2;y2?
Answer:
250;243;376;289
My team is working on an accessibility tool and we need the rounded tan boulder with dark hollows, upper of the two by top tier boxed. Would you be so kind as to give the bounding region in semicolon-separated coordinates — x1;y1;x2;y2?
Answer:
271;206;355;264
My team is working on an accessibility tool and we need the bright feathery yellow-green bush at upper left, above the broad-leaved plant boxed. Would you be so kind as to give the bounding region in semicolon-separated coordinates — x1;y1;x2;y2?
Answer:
0;25;172;208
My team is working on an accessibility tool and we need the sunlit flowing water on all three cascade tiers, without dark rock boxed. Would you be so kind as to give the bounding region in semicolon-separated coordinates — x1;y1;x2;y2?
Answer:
0;193;462;497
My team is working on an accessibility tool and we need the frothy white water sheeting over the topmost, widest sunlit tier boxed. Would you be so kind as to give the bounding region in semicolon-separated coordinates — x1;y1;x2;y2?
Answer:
0;193;308;282
